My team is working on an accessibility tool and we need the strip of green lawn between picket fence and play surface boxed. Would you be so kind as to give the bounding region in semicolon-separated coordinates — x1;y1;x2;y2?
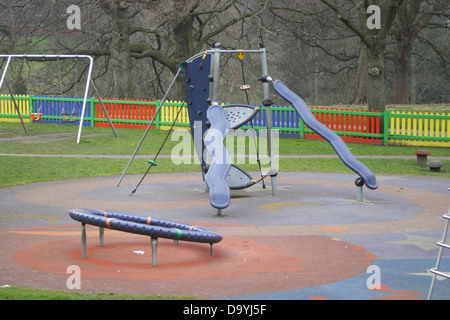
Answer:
0;122;450;187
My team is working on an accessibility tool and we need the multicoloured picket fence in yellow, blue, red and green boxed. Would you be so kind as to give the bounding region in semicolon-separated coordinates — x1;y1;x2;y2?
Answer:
0;95;450;147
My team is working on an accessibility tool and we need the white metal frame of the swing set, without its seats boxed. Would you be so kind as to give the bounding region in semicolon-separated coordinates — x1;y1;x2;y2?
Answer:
0;54;117;144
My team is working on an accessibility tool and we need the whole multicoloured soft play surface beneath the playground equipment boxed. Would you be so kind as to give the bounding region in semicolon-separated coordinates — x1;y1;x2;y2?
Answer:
0;172;450;300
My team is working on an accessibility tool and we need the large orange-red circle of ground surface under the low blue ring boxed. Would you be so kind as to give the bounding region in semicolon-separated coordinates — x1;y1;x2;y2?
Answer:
0;226;375;298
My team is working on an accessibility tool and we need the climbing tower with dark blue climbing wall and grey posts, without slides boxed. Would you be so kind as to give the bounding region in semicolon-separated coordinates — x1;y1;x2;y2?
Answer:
117;43;278;215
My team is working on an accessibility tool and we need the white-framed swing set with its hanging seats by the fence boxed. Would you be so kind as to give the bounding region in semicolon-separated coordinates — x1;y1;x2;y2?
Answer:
0;54;118;144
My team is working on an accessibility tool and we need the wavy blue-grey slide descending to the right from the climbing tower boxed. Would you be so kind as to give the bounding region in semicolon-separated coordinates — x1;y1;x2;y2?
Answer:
273;80;378;190
